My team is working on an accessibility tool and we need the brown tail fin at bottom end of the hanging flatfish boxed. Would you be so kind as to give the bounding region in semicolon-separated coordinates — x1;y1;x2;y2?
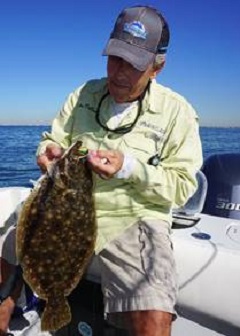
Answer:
41;296;71;331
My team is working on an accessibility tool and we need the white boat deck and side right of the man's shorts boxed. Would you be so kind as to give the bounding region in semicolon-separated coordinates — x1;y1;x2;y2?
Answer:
173;214;240;336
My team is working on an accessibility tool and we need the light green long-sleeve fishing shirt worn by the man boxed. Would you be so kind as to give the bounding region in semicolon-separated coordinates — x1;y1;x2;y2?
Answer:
37;78;202;252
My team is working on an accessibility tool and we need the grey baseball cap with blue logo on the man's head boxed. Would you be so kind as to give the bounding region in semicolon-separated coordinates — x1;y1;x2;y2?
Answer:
103;6;170;71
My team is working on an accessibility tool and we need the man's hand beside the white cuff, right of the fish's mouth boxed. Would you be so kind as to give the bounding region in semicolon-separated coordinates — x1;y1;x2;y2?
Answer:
88;150;124;179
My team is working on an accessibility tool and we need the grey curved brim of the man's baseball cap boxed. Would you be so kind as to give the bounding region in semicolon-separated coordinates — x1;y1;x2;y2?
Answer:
102;39;155;71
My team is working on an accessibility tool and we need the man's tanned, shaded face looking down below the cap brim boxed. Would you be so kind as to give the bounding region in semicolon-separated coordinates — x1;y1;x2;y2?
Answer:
107;56;156;103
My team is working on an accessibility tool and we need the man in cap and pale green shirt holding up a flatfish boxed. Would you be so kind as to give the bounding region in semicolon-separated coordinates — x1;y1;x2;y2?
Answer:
37;6;202;336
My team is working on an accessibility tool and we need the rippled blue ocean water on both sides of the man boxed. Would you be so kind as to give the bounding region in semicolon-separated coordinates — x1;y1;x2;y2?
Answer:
0;126;240;187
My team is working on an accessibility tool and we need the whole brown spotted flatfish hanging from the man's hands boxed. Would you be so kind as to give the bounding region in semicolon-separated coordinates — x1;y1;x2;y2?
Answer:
16;141;97;331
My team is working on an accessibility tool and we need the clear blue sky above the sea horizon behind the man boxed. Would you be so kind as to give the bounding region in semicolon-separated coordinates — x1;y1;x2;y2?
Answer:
0;0;240;126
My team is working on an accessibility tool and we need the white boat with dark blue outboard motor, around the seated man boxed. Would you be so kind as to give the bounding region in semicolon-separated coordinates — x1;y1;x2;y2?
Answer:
0;153;240;336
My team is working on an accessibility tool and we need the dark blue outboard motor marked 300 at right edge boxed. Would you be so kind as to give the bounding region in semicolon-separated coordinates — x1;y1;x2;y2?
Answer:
202;153;240;219
